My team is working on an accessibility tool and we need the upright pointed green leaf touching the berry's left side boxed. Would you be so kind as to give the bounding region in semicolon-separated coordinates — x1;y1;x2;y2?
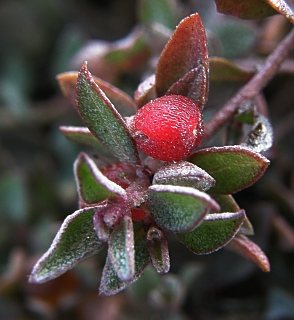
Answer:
77;63;139;164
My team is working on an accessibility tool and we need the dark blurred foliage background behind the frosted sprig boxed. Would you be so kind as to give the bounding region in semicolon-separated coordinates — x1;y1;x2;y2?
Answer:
0;0;294;320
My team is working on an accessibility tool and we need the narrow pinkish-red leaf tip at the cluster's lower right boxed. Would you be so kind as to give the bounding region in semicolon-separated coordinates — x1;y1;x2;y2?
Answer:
227;234;270;272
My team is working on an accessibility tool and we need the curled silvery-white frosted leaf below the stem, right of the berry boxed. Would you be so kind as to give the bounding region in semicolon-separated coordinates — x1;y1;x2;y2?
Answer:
241;115;274;152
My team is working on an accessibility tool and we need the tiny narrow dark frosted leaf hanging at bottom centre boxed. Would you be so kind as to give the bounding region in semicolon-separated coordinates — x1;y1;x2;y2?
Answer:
147;226;170;274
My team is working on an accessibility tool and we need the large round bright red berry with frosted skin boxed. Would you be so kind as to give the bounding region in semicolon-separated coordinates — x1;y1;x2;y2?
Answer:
130;95;203;161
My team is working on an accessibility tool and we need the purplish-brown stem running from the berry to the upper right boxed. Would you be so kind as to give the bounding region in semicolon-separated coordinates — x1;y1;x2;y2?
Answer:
202;29;294;144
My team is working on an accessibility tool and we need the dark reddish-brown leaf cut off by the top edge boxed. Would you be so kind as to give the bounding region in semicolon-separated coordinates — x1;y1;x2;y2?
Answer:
214;0;276;19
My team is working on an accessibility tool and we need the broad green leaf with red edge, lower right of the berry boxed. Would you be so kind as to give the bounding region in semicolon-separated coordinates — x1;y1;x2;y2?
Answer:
189;146;269;194
